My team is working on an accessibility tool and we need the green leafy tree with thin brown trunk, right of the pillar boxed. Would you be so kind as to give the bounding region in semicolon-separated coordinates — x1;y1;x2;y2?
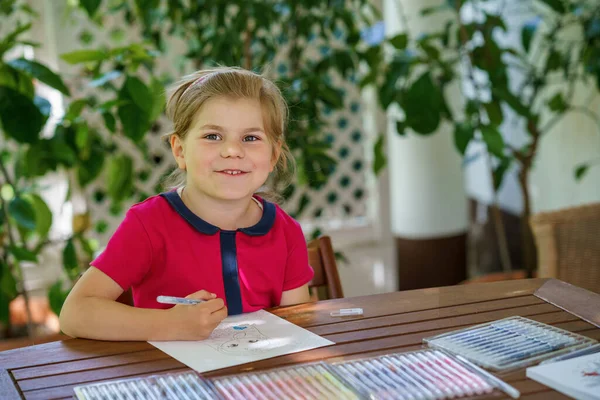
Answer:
376;0;600;276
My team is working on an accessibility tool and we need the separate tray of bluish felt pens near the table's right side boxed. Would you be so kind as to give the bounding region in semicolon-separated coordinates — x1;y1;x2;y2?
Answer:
423;317;596;372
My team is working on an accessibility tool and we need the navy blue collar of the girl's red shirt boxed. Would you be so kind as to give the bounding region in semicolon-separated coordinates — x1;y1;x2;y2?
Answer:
160;190;276;236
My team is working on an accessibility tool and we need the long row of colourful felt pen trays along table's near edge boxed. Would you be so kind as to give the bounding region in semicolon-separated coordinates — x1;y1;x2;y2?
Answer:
75;349;519;400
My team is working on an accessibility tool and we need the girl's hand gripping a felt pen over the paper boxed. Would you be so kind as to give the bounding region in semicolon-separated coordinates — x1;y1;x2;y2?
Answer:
166;290;227;340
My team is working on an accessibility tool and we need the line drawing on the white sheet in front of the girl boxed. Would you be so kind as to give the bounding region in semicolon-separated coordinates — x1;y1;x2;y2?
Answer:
206;324;273;356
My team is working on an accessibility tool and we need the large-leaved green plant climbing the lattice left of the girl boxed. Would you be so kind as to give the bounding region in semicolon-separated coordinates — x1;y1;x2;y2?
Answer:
0;1;164;335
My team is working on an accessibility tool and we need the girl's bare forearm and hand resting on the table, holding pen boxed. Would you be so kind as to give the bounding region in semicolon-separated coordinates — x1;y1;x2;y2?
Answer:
60;267;227;340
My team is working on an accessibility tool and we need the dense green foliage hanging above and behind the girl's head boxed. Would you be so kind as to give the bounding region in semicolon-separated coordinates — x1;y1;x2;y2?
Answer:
80;0;377;216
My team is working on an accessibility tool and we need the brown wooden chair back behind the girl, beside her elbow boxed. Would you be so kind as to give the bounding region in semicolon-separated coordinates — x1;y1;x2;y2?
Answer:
308;236;344;300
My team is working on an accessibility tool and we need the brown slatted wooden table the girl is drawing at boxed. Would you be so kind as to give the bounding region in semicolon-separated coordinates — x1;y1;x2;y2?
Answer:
0;279;600;400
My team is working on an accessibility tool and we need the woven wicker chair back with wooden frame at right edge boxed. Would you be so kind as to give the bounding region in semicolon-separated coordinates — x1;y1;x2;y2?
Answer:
530;203;600;293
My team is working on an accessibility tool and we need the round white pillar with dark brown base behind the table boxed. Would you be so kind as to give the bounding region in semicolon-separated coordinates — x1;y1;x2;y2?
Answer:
384;0;468;289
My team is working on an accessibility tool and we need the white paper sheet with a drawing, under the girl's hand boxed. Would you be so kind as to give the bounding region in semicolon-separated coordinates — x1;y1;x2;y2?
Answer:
148;310;335;372
